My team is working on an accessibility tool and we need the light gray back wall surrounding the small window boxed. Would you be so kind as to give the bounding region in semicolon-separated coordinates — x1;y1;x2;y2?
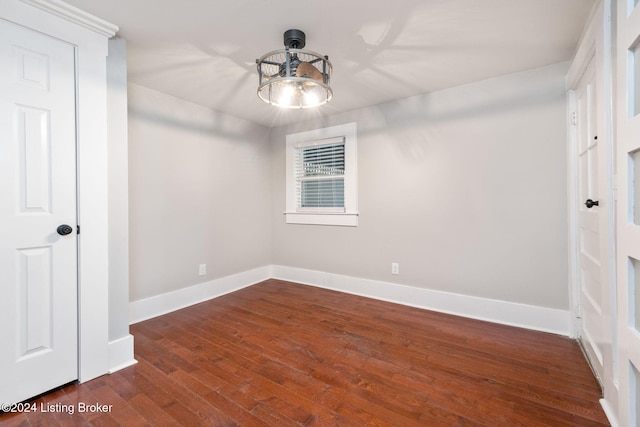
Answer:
270;63;568;309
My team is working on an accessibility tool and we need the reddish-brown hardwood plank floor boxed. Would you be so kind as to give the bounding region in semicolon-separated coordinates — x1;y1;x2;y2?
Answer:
0;280;608;427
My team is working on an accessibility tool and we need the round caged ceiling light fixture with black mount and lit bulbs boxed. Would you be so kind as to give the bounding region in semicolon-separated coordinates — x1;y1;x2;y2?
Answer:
256;30;333;108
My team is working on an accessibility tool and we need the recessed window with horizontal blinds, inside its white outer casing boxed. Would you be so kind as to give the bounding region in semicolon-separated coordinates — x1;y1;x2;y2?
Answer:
296;138;345;209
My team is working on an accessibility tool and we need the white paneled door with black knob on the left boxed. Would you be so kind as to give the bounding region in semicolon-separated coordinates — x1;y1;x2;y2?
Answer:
0;20;78;402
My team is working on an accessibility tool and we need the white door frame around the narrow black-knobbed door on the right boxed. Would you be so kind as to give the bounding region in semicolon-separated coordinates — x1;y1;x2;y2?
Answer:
567;0;618;420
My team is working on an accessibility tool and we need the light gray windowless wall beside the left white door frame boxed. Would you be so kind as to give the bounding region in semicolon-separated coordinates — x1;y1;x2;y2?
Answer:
129;84;271;301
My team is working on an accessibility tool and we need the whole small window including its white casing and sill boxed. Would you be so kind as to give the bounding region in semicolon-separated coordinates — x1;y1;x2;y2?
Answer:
285;123;358;226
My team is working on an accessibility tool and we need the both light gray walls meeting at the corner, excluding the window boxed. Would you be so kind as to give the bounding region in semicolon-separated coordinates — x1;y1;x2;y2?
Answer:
129;63;568;309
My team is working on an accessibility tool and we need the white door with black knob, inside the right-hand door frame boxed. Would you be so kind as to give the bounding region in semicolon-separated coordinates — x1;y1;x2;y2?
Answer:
575;58;608;384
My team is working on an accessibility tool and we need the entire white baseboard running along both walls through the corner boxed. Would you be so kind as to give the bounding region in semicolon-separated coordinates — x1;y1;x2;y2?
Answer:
129;265;572;336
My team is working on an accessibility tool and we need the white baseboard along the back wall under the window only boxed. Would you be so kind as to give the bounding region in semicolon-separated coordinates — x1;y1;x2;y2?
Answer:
271;265;572;336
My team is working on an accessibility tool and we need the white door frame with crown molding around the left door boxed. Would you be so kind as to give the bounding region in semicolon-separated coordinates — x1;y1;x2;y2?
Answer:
0;0;118;382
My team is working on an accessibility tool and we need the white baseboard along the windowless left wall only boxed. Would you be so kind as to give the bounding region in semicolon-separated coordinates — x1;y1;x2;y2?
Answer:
129;266;271;324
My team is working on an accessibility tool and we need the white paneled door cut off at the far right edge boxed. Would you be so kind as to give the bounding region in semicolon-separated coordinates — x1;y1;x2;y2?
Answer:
616;0;640;426
